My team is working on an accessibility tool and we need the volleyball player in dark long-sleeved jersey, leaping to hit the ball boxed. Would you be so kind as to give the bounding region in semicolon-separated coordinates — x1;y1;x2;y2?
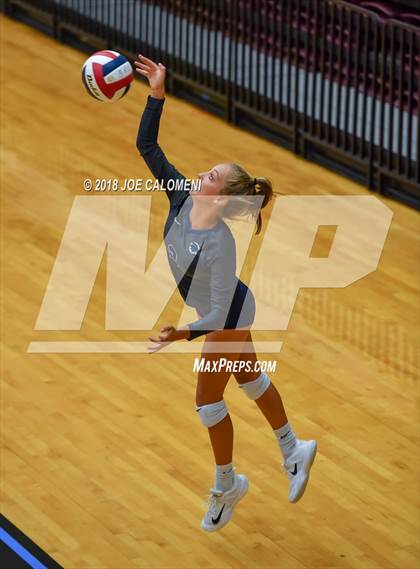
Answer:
135;55;317;531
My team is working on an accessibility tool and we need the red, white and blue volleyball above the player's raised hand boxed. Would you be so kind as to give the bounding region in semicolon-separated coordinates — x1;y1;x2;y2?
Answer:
82;50;133;103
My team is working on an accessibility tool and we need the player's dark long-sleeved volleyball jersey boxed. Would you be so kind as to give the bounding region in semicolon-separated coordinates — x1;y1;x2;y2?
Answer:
137;96;255;340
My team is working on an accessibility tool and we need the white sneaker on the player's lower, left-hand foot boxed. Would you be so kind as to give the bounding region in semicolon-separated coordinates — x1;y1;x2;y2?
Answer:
201;468;249;531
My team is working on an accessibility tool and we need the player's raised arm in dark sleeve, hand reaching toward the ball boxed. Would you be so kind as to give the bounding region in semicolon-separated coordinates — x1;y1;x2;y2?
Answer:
134;55;185;201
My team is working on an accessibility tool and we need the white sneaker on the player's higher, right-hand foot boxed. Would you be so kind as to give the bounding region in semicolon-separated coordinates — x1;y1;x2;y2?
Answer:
284;439;316;502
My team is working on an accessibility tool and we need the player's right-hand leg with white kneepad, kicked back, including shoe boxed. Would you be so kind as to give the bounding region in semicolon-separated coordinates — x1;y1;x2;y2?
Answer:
234;332;316;502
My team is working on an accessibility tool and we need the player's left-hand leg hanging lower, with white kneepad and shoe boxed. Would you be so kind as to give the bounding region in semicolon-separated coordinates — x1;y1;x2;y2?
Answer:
196;330;248;531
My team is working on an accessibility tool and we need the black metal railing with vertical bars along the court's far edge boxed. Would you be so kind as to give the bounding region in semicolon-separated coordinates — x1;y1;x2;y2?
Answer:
4;0;420;206
